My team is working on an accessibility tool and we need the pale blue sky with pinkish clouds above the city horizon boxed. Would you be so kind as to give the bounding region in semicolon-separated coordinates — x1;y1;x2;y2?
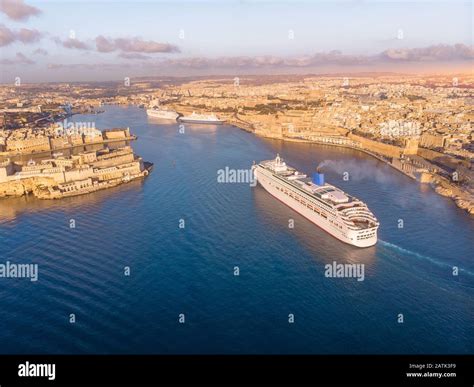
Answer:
0;0;474;83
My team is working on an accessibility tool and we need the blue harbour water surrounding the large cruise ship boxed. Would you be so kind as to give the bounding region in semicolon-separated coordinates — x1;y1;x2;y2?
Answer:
0;106;474;354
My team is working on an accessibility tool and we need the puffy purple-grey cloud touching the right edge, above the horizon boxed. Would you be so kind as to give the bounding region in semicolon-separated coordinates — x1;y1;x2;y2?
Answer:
380;44;474;61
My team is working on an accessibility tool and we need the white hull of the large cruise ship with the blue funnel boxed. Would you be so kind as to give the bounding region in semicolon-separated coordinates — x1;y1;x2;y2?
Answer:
254;166;377;247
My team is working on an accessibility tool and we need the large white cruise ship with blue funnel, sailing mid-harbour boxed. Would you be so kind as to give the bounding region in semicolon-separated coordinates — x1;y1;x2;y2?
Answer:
252;155;379;247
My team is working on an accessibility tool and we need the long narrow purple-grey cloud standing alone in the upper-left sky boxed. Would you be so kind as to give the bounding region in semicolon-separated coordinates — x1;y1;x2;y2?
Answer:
95;35;179;54
